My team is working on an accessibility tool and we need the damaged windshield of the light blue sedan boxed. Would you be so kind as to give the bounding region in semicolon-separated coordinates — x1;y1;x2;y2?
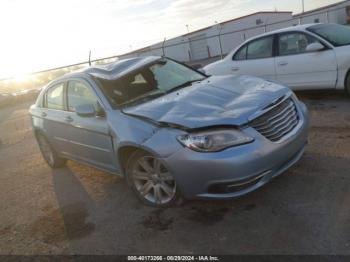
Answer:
98;59;205;106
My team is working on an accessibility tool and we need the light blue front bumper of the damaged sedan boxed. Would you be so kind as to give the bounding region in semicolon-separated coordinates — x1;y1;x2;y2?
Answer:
163;99;309;199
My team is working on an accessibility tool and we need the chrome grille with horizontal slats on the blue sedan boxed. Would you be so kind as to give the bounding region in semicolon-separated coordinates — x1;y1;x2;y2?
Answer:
250;98;299;142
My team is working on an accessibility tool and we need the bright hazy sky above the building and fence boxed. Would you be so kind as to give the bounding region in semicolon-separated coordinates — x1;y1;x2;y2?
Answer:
0;0;339;78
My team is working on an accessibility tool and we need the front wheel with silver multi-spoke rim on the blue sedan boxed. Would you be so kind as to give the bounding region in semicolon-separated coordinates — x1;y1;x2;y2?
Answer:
126;150;182;207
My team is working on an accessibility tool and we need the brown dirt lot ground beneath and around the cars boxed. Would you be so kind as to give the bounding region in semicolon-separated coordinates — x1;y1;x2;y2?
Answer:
0;92;350;254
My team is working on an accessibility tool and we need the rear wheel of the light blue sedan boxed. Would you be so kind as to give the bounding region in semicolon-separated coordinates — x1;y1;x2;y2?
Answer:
36;134;67;168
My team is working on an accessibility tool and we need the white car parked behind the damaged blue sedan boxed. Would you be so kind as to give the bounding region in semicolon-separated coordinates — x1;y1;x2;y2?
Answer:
203;24;350;94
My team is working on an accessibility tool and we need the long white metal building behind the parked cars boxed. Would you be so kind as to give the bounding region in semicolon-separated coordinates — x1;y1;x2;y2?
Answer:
121;0;350;62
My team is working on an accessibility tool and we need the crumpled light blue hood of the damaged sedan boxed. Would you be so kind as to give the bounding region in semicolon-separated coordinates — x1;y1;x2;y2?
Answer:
123;76;290;128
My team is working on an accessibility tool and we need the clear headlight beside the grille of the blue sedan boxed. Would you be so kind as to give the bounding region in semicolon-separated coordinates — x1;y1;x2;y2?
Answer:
177;129;254;152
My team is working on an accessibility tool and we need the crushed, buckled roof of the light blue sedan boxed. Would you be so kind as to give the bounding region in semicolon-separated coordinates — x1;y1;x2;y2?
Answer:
55;56;161;82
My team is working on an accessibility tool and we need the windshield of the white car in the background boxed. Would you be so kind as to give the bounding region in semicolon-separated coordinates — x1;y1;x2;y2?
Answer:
307;24;350;46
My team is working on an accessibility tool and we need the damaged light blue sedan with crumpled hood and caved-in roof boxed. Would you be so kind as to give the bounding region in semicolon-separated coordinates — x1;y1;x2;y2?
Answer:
30;57;308;206
